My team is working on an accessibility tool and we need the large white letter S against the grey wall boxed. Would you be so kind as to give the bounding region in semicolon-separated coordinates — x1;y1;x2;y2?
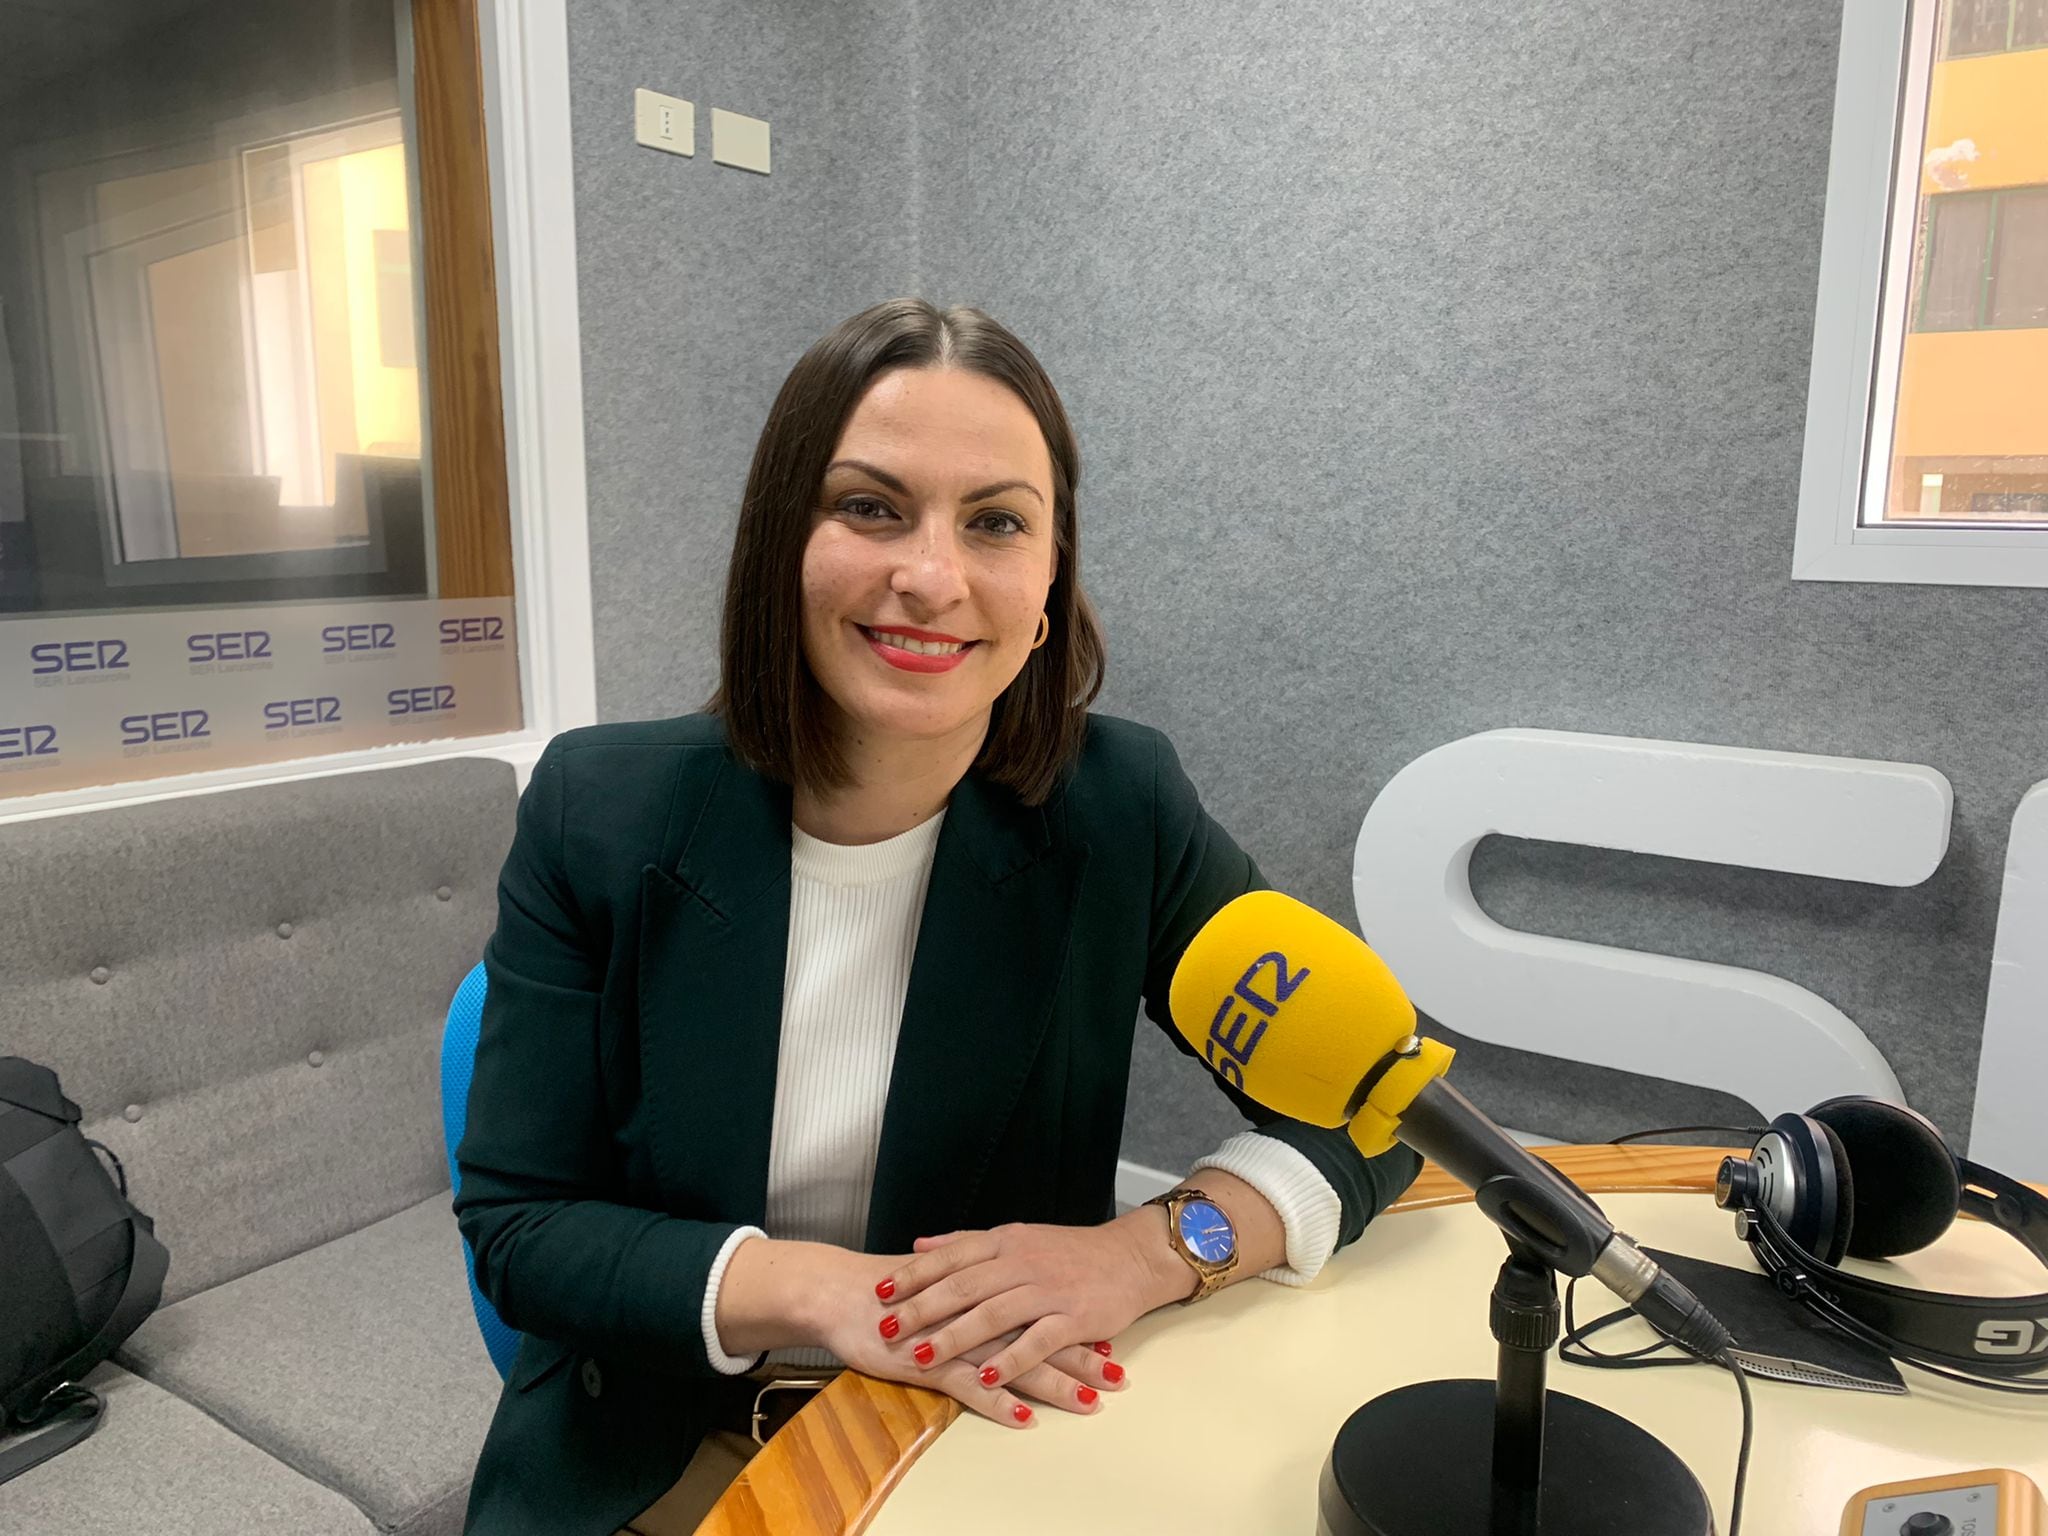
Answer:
1352;729;1949;1116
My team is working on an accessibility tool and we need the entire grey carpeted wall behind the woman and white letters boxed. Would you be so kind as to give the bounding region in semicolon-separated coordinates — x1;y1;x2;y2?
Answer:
569;0;2048;1167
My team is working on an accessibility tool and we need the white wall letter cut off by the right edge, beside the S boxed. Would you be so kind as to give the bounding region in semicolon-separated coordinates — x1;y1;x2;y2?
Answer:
1970;782;2048;1180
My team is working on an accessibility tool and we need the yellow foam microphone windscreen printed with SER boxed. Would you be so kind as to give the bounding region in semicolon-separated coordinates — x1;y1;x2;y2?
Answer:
1167;891;1425;1126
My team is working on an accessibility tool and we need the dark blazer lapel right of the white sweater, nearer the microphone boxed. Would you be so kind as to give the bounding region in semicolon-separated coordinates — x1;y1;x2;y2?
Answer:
866;774;1087;1253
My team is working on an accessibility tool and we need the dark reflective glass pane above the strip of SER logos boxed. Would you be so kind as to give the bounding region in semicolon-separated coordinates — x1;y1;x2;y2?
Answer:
0;0;432;612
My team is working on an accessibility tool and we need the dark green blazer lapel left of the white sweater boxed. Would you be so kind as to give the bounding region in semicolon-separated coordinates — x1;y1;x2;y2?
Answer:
639;756;791;1225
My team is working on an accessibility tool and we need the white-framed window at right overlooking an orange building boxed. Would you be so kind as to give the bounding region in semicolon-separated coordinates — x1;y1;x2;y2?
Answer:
1792;0;2048;586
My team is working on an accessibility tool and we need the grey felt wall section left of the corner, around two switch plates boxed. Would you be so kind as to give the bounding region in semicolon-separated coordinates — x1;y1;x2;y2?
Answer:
569;0;915;719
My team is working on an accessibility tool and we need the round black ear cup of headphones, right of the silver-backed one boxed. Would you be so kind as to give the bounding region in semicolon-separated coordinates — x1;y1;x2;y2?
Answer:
1810;1096;1962;1260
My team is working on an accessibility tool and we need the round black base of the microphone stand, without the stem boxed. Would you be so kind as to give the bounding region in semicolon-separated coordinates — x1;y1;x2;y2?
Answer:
1315;1378;1714;1536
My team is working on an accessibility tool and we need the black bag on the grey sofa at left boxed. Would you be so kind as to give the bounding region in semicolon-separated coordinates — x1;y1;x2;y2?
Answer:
0;1057;170;1483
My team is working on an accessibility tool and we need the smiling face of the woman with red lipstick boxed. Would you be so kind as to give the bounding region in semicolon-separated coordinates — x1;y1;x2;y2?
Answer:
803;369;1057;765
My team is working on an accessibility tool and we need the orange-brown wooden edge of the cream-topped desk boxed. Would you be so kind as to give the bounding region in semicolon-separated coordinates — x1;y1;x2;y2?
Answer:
696;1145;1726;1536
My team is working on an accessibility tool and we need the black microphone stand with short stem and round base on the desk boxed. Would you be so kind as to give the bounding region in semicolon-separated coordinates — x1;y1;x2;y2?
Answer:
1317;1239;1714;1536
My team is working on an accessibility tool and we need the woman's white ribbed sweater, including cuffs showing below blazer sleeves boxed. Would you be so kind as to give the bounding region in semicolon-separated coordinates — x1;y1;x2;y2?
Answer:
700;811;1341;1374
